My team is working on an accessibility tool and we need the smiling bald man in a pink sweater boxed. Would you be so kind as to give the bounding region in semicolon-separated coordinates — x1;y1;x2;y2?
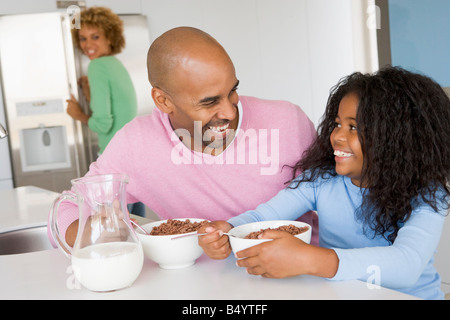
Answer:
49;27;316;245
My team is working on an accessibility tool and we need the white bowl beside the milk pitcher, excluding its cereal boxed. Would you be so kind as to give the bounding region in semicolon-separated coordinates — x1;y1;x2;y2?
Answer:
136;218;205;269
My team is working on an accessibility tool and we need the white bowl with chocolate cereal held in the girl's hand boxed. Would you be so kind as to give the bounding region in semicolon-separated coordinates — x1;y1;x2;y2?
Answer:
228;220;312;253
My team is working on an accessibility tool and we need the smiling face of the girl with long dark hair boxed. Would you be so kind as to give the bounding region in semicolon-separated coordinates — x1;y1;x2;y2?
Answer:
330;93;363;186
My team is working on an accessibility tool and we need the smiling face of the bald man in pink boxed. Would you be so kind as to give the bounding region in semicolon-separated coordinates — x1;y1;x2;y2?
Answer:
163;53;239;154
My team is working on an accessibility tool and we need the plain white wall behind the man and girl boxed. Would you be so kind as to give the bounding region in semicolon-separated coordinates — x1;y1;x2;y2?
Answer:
140;0;376;125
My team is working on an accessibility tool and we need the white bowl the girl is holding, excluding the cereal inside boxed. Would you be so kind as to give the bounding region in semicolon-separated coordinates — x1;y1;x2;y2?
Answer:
228;220;312;254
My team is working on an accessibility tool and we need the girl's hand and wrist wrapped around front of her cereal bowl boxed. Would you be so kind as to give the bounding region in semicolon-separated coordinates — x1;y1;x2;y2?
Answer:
236;230;339;278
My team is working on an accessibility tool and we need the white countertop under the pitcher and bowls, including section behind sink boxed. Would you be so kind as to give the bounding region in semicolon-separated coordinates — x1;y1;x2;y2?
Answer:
0;187;415;300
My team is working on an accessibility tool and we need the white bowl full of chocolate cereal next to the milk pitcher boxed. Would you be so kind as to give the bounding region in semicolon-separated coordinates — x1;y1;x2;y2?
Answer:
136;218;208;269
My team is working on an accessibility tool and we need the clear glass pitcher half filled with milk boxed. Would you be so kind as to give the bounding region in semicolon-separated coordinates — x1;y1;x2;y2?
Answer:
50;174;144;291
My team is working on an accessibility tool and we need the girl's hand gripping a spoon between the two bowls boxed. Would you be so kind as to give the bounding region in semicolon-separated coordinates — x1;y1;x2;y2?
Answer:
197;221;232;259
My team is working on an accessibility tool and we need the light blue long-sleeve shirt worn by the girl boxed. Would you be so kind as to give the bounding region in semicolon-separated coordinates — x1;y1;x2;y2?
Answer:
228;176;446;299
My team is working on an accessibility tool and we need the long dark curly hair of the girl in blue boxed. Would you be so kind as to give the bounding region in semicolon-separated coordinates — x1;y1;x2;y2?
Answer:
290;67;450;243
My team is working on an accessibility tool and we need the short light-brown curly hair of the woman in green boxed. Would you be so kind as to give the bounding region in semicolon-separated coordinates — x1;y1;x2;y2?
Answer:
72;7;125;55
